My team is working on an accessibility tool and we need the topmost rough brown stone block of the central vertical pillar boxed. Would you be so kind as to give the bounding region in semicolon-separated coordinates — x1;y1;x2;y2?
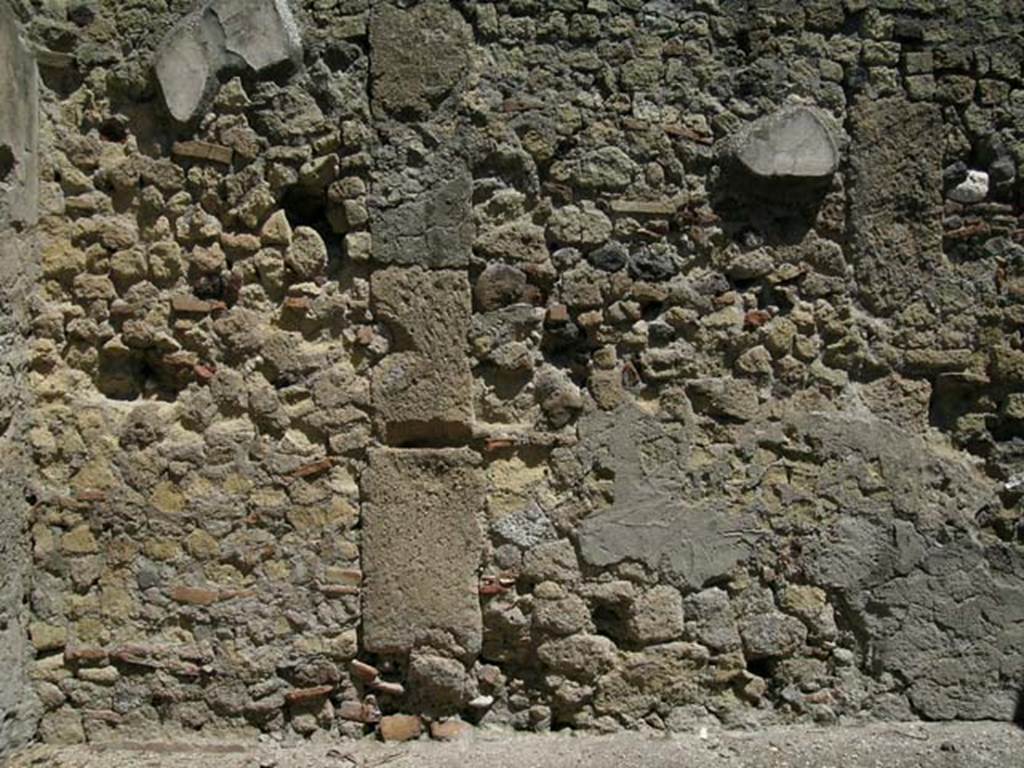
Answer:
370;0;473;118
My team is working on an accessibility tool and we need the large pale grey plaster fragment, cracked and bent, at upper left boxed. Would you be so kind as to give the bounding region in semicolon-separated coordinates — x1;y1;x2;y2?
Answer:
155;0;302;123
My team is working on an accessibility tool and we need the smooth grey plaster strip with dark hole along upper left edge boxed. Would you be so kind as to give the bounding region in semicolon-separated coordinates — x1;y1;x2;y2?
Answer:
0;9;39;229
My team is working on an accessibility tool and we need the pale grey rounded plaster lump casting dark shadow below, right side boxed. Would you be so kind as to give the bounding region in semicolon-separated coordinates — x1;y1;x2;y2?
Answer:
735;106;839;181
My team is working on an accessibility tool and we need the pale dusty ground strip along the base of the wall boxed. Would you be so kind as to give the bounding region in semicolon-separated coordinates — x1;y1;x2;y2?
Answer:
8;723;1024;768
